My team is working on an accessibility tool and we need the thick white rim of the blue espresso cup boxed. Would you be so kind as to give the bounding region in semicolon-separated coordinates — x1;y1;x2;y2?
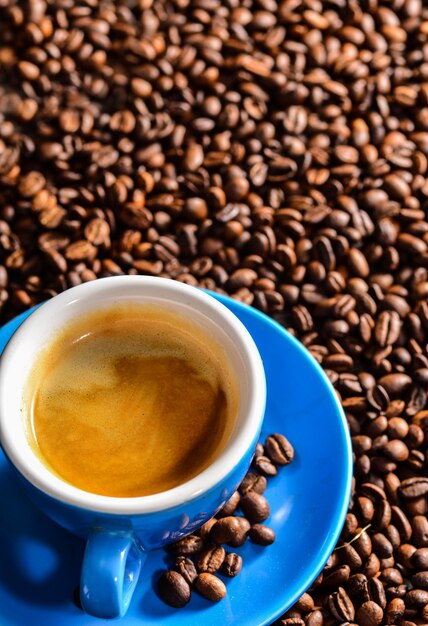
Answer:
0;276;266;515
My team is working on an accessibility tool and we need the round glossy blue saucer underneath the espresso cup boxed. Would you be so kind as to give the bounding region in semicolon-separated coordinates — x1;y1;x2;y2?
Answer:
0;296;352;626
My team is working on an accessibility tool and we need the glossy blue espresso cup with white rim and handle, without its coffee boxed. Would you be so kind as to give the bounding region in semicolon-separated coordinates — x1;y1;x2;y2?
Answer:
0;276;266;618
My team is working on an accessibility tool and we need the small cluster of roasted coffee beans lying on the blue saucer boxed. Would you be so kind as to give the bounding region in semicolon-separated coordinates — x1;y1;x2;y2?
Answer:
158;433;294;608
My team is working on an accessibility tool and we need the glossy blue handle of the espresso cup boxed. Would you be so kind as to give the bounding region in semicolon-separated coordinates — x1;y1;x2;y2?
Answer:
80;529;145;618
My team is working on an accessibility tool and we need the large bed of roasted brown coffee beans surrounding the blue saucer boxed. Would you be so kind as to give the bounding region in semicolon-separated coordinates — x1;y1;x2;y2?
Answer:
0;0;428;626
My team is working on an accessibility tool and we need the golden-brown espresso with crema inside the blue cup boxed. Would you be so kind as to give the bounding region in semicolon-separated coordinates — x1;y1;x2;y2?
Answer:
24;305;239;497
